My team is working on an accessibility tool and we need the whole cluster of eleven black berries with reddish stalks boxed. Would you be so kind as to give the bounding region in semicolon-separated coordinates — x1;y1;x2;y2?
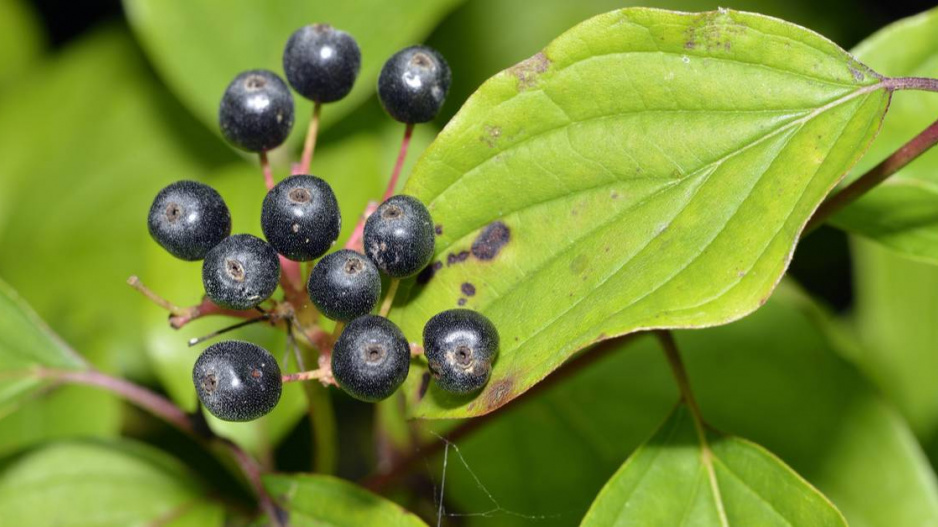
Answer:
139;24;499;421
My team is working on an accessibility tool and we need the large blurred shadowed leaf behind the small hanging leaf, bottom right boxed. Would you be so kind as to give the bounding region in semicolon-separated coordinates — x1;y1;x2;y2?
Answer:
430;282;938;527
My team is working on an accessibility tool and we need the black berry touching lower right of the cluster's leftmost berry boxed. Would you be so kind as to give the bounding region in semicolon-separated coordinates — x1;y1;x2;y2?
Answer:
202;234;280;309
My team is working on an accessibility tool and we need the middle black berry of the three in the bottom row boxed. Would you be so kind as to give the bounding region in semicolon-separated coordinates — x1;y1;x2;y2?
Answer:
332;315;410;402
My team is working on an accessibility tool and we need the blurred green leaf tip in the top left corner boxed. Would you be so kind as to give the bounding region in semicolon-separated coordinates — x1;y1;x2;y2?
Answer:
0;0;45;86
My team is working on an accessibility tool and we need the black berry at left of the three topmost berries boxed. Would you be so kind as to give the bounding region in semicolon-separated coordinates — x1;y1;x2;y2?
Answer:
218;70;293;152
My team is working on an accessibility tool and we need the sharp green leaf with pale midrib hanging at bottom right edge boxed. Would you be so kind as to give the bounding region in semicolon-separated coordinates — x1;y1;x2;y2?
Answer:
581;405;847;527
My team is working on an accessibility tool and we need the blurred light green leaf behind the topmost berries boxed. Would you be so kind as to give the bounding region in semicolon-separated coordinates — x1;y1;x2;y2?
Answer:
124;0;460;144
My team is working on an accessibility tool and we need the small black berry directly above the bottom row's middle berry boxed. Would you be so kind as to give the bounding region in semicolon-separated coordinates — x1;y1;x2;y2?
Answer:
306;249;381;321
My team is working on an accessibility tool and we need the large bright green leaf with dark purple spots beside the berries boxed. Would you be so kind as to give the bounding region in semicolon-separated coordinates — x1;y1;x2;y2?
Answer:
394;8;889;418
